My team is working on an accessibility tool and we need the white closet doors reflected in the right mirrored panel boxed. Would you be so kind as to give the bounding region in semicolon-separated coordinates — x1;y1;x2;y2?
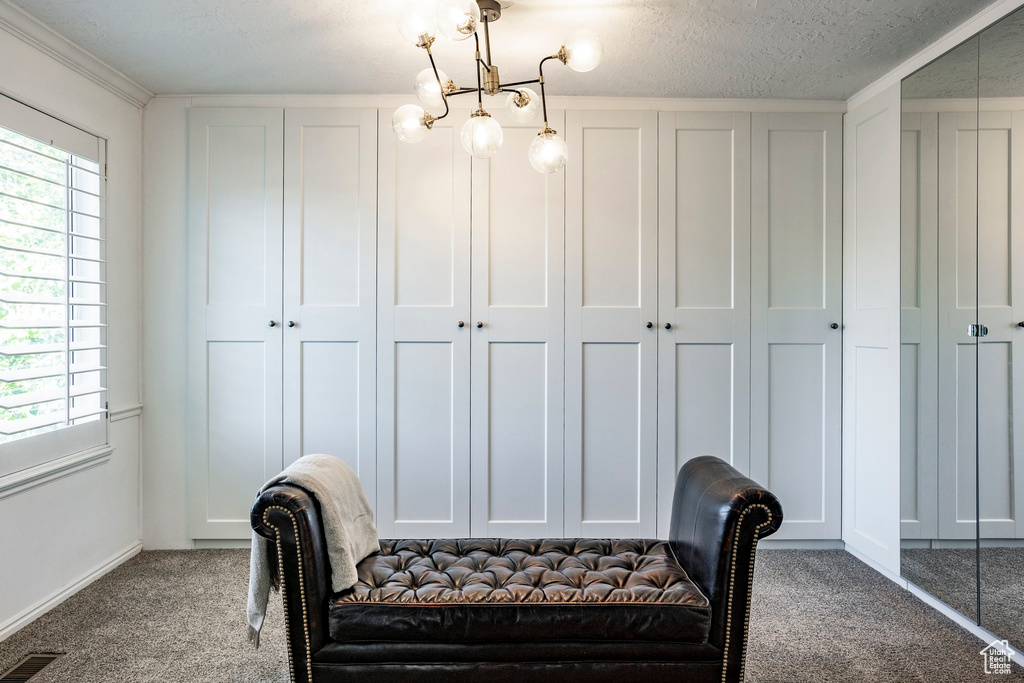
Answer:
978;112;1024;539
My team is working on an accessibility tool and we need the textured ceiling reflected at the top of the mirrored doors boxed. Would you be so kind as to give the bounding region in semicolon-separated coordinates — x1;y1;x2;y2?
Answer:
903;5;1024;99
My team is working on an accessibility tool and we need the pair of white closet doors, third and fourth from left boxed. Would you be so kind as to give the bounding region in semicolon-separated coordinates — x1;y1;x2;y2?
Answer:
377;112;564;538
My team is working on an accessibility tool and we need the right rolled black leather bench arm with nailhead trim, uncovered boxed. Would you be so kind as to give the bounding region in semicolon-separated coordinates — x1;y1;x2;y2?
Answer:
669;456;782;681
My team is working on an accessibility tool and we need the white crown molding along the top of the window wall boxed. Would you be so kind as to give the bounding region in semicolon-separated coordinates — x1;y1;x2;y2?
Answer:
0;0;154;109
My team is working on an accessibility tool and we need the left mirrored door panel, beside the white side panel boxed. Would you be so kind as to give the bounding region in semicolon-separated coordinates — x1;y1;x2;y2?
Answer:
900;37;987;620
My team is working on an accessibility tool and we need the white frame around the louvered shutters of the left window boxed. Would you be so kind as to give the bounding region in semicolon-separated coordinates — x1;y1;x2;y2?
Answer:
0;94;110;477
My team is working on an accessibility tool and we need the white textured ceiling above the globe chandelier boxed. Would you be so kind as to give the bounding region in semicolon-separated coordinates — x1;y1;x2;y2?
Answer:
9;0;991;99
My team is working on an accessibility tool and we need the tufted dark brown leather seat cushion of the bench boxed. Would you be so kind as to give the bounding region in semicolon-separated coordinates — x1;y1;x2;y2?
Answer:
329;539;711;643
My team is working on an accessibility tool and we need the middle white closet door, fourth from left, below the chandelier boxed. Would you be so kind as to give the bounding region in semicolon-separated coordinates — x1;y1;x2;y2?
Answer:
467;111;565;538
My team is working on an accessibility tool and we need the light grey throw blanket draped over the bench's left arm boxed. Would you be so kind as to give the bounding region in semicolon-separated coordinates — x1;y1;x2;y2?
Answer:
247;455;380;648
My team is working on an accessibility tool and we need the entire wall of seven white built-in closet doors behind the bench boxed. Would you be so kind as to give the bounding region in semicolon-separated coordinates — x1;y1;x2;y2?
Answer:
189;104;842;539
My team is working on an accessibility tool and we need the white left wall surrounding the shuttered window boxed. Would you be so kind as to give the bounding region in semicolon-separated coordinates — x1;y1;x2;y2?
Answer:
0;25;142;639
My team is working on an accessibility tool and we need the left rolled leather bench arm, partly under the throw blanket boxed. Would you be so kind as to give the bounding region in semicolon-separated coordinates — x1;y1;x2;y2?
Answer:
250;484;331;682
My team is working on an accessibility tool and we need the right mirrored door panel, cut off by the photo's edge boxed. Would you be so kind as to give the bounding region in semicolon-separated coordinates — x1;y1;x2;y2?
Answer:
978;5;1024;647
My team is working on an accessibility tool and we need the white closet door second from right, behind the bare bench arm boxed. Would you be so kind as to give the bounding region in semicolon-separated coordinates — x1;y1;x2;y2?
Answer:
657;113;751;538
